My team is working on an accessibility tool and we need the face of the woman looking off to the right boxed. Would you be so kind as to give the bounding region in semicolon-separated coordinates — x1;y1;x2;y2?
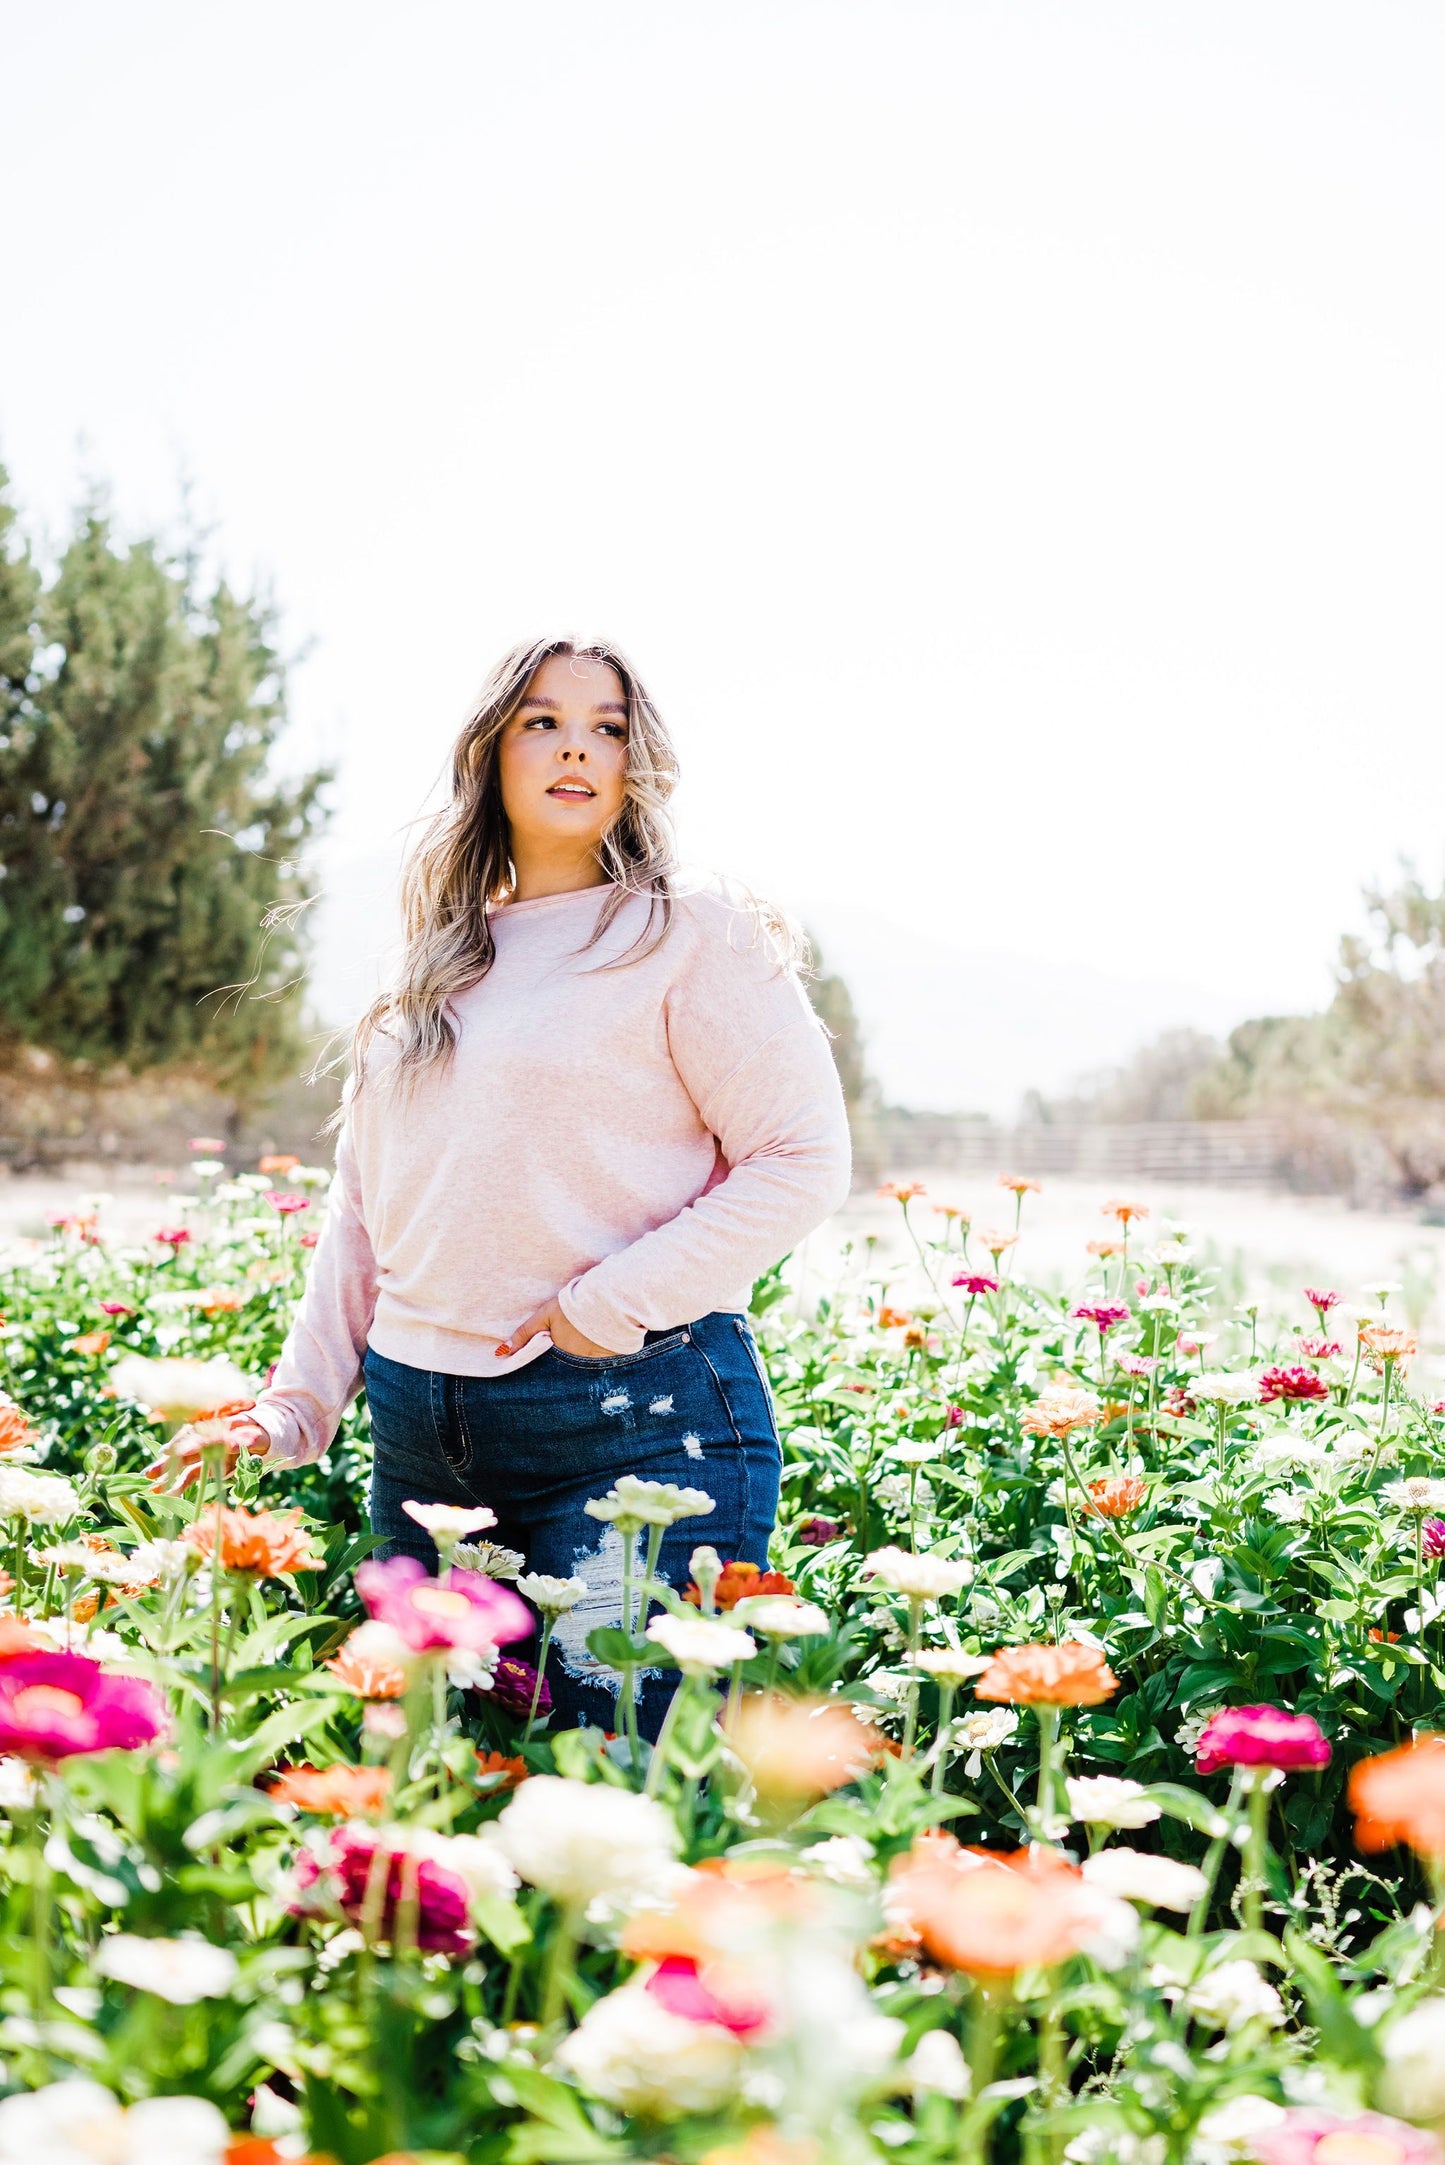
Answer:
498;654;628;862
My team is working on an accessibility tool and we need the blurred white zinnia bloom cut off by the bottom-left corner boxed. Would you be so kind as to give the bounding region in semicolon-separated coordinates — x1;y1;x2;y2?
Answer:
0;2081;230;2165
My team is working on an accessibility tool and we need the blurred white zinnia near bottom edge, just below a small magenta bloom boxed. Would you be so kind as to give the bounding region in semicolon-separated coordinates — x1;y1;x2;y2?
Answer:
548;1983;743;2120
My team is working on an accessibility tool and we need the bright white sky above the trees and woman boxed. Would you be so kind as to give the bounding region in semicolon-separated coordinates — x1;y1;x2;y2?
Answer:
0;0;1445;1106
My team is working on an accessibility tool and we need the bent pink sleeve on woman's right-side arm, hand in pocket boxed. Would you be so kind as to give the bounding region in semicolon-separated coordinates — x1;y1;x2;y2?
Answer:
559;913;851;1353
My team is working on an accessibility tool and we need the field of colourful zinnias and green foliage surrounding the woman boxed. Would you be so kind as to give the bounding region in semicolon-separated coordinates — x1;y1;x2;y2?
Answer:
0;1150;1445;2165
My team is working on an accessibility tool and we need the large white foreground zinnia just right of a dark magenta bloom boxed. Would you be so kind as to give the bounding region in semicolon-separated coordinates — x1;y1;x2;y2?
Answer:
492;1773;680;1905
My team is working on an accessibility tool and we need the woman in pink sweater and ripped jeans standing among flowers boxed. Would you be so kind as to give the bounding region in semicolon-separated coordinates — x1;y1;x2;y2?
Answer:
152;639;851;1734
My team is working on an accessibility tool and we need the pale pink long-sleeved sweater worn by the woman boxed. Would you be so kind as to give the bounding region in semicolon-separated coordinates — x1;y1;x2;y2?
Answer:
256;888;851;1466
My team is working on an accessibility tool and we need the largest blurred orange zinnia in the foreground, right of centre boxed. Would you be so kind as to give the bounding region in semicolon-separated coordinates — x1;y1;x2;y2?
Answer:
886;1834;1098;1977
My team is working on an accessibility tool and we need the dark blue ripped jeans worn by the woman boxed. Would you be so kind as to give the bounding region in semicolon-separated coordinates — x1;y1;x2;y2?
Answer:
364;1310;782;1736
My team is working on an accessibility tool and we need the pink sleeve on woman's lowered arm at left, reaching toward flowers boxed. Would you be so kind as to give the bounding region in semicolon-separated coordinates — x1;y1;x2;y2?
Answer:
256;1124;377;1466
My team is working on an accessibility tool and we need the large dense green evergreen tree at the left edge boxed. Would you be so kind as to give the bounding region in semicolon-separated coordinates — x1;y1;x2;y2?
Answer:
0;491;329;1100
